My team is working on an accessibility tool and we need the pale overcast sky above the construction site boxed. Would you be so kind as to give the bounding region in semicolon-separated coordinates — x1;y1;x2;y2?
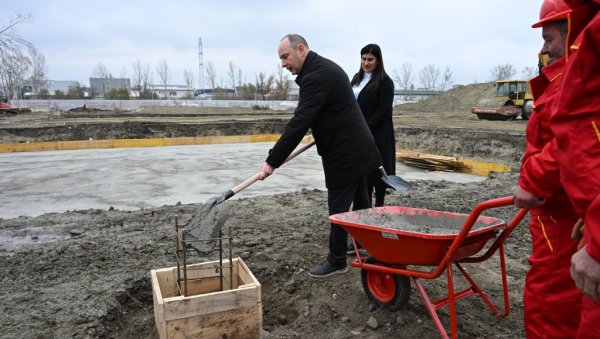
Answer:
0;0;542;87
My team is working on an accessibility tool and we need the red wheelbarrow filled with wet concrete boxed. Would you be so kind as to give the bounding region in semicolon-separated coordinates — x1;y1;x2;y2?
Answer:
329;197;527;338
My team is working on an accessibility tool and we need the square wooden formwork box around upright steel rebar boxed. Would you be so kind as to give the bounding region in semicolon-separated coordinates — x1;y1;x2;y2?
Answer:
150;258;262;339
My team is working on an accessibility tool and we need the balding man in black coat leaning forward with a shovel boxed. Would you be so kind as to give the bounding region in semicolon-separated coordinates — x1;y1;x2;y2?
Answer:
260;34;381;278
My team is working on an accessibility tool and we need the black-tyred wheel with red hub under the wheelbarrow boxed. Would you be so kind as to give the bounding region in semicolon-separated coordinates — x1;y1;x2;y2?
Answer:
361;257;410;311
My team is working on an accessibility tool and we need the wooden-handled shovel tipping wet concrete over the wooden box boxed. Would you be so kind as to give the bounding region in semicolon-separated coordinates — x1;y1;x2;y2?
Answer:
185;140;315;254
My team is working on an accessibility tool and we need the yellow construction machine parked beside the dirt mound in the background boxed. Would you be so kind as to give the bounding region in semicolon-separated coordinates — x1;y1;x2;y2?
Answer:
471;54;548;120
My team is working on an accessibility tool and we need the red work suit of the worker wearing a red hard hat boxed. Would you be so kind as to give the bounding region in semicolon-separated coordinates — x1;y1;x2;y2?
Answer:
519;58;582;338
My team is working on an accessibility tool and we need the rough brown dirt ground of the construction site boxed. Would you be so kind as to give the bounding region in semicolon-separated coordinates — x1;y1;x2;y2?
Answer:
0;85;530;338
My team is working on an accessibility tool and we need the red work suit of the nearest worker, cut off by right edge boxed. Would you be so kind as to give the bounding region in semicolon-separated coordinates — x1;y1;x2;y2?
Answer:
551;0;600;338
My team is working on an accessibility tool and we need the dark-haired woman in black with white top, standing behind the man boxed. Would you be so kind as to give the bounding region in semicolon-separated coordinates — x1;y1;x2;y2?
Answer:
350;44;396;206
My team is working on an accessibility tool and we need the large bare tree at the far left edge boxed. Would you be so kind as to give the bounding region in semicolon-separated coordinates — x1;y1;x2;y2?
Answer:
0;15;33;98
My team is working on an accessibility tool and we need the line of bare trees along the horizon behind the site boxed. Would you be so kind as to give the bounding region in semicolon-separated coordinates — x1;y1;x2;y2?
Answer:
0;15;537;100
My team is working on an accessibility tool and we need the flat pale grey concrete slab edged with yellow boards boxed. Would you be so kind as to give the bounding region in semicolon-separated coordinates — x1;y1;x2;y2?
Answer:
0;142;485;219
